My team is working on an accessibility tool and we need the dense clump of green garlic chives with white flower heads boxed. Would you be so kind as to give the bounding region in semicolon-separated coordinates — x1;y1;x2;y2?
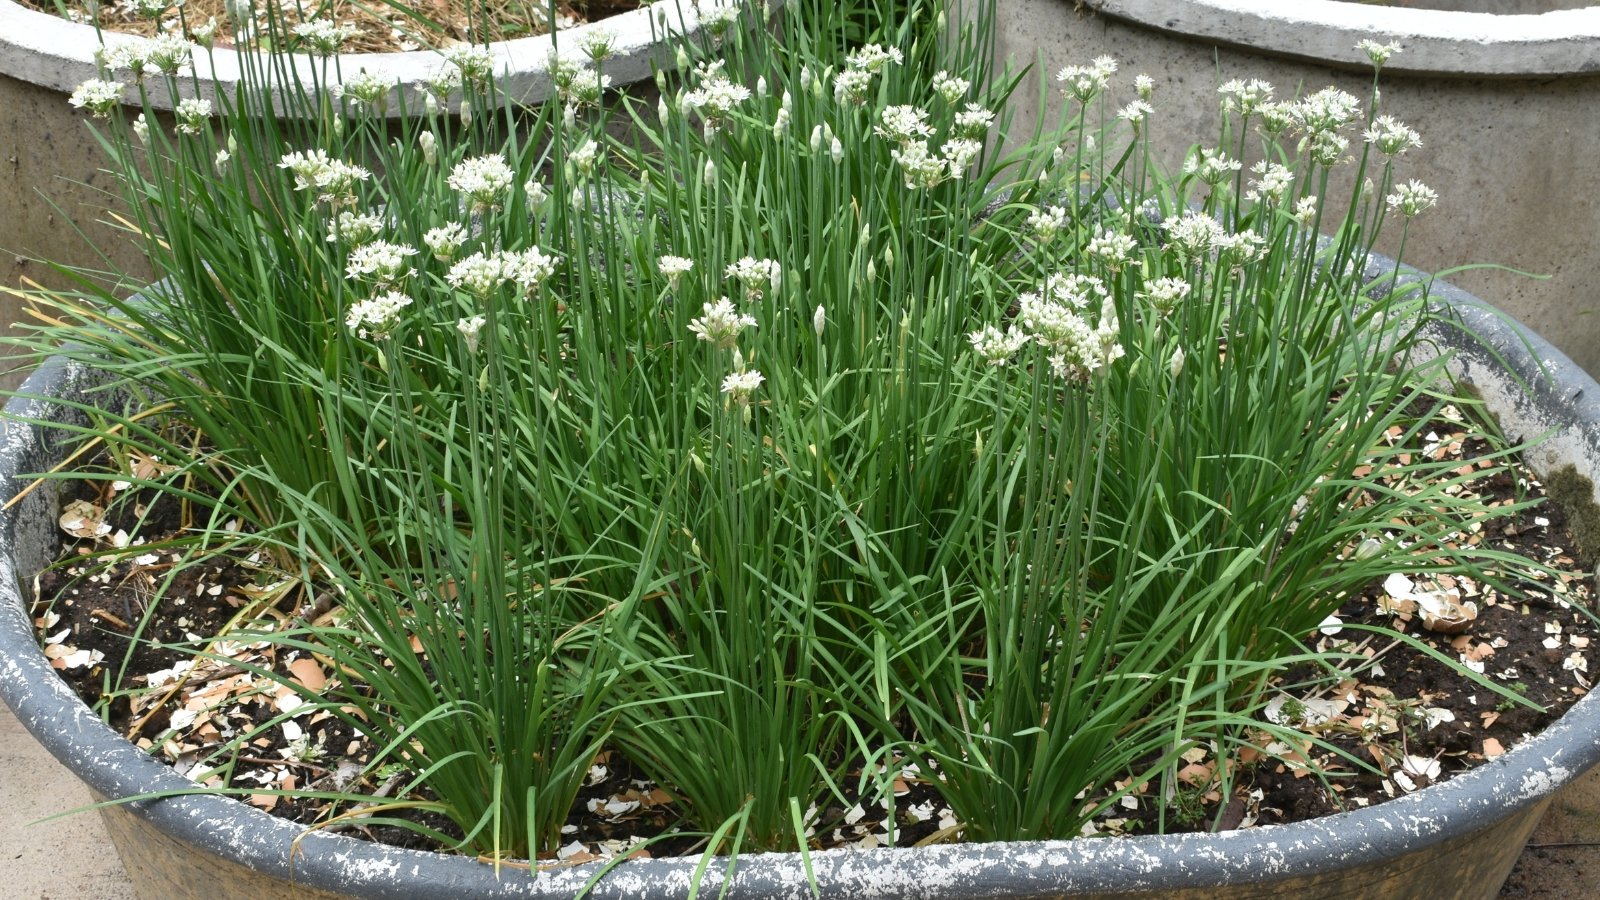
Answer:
0;3;1548;860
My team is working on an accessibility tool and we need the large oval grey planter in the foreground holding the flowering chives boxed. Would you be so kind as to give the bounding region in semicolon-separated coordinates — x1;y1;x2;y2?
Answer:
0;256;1600;900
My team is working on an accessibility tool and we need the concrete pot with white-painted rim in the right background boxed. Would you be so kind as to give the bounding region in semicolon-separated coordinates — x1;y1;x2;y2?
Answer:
997;0;1600;372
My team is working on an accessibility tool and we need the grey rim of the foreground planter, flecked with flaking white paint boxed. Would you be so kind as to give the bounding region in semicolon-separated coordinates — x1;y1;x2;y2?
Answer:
0;258;1600;900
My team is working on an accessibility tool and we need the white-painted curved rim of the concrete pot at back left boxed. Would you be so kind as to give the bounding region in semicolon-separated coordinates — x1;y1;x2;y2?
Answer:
0;0;734;119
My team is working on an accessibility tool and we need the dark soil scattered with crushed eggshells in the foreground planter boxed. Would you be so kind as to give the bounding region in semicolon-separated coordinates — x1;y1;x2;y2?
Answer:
35;408;1597;863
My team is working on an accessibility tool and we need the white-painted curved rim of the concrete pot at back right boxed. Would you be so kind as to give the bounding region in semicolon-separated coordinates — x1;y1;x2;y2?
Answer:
1088;0;1600;78
